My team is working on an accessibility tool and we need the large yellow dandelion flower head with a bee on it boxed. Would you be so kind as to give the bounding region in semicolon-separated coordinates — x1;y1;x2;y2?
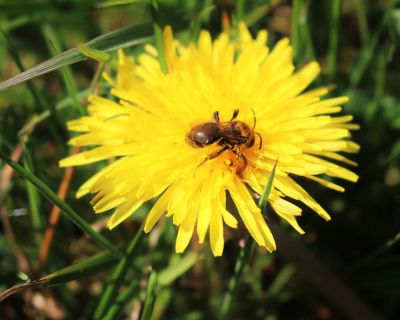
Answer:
60;24;359;256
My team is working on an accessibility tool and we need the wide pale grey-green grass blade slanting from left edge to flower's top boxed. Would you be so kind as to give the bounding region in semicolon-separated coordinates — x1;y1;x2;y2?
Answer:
0;23;152;90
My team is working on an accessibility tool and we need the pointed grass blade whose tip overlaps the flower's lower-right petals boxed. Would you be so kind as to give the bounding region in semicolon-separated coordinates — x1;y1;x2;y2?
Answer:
219;159;278;320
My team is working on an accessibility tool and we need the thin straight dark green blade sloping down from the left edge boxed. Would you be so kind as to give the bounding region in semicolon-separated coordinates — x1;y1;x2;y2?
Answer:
0;151;122;256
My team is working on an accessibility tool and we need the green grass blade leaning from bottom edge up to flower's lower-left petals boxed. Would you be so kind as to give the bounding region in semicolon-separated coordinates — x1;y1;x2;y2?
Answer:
93;223;144;319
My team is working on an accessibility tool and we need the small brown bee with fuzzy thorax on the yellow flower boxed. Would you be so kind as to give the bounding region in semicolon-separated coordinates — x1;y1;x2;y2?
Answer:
186;109;262;176
